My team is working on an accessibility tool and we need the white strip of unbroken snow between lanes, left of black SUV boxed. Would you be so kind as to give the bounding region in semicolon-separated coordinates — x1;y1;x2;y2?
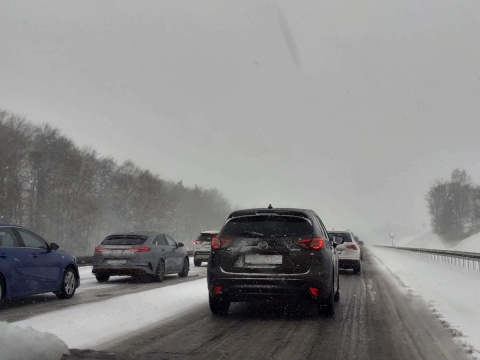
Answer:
13;279;208;350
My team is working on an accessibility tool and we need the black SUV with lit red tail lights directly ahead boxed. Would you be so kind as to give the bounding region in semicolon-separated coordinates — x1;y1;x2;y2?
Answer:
207;208;341;316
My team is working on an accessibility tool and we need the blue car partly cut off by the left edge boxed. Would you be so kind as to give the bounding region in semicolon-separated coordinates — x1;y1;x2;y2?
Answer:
0;223;80;300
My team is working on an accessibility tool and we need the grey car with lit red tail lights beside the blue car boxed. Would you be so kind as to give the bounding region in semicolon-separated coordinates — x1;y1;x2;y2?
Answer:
92;231;190;282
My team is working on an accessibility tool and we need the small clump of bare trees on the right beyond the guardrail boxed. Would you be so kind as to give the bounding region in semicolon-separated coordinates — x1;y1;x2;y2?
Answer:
426;169;480;242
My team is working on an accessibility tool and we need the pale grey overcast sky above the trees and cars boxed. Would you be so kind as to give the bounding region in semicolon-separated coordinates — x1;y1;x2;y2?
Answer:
0;0;480;242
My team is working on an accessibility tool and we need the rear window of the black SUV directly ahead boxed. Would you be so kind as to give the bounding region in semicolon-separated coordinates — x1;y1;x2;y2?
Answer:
221;215;313;238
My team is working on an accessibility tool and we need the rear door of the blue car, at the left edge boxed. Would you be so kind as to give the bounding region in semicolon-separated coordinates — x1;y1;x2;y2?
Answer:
0;227;36;297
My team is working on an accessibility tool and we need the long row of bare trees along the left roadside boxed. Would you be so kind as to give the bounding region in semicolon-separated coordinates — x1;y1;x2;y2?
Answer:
0;110;232;256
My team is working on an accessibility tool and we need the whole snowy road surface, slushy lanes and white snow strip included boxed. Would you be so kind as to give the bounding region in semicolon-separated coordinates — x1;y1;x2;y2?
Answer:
0;250;471;360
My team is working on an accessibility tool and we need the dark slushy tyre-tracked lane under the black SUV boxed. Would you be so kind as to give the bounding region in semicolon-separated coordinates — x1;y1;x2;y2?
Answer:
57;251;471;360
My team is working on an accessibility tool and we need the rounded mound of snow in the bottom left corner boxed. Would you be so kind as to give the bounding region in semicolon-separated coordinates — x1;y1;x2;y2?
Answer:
0;321;70;360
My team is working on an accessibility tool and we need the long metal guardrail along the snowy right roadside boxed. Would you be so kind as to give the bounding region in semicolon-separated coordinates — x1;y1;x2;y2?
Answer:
374;245;480;271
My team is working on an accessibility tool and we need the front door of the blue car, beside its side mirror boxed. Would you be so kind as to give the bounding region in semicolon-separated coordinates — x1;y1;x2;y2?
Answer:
15;228;63;293
